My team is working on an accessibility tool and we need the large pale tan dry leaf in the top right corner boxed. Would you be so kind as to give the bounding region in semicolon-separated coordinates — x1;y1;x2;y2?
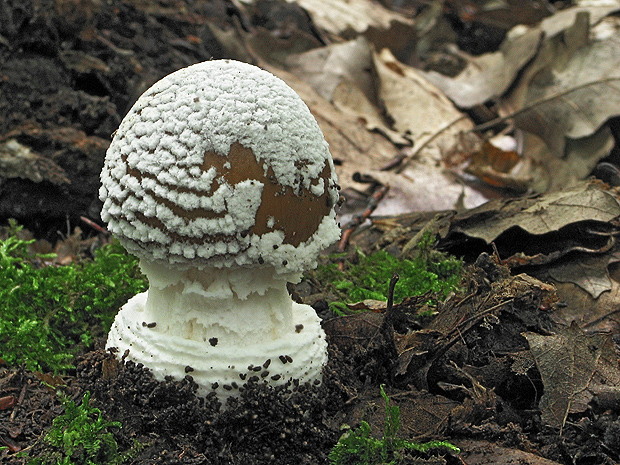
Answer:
500;4;620;157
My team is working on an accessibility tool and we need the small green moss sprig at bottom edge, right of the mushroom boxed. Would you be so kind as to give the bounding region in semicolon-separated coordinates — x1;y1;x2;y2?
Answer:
329;386;460;465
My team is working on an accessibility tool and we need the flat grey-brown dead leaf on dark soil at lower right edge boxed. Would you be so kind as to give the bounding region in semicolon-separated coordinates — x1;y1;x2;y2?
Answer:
523;323;620;429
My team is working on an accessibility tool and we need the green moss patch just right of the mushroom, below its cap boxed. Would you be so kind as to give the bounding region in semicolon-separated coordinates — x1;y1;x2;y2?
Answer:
316;239;463;313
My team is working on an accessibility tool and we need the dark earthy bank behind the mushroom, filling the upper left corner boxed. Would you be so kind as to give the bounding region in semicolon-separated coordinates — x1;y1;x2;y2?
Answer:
0;0;298;242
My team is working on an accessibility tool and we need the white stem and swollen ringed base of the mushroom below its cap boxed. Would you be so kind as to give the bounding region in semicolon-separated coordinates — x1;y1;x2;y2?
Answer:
106;260;327;404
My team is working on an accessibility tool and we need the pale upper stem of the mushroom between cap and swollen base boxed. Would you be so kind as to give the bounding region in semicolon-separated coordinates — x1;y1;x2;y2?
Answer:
140;259;298;346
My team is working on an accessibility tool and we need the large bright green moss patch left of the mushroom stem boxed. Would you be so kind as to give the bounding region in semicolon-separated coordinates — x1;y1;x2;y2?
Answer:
0;225;147;372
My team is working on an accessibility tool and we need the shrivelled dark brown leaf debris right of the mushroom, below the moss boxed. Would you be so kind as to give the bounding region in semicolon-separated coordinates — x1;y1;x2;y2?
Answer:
394;264;557;389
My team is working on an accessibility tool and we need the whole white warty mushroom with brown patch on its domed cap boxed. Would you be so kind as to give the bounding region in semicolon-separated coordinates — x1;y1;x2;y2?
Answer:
99;60;340;401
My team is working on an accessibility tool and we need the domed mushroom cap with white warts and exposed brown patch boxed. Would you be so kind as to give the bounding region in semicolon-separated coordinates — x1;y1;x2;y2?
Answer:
99;60;340;272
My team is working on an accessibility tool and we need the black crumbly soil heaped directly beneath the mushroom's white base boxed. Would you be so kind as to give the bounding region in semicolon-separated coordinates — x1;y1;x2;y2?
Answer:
69;350;346;464
